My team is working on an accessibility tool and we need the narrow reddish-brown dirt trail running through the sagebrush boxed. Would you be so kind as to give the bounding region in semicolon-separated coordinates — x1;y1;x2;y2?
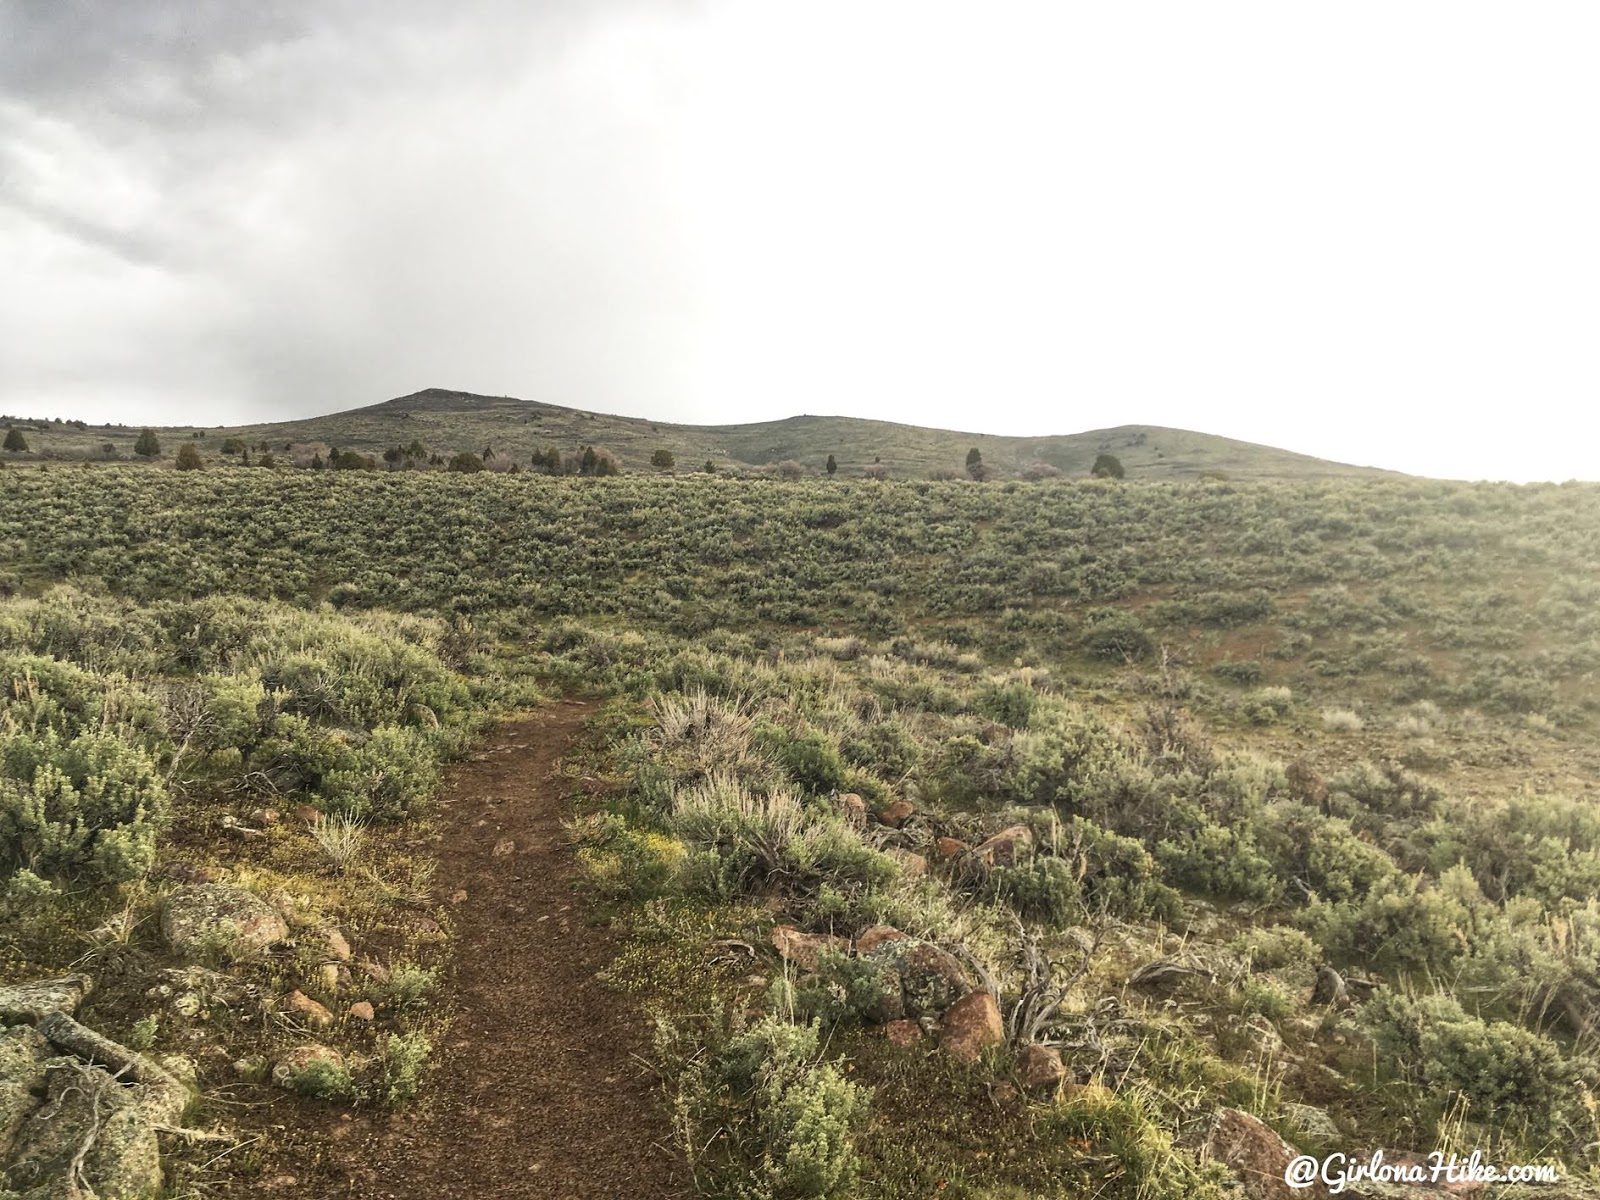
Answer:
286;702;685;1200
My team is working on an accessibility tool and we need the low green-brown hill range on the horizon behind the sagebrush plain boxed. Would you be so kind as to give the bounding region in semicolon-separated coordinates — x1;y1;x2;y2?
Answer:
0;387;1394;478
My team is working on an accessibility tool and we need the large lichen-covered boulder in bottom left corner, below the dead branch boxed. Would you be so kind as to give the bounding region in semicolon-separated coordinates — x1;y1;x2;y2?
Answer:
6;1058;162;1200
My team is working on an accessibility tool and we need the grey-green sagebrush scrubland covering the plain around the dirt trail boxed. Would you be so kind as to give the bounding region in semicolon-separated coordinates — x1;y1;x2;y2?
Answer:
0;467;1600;1200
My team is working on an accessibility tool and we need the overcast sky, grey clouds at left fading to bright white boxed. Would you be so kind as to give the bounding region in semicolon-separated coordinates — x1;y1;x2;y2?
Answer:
0;0;1600;478
